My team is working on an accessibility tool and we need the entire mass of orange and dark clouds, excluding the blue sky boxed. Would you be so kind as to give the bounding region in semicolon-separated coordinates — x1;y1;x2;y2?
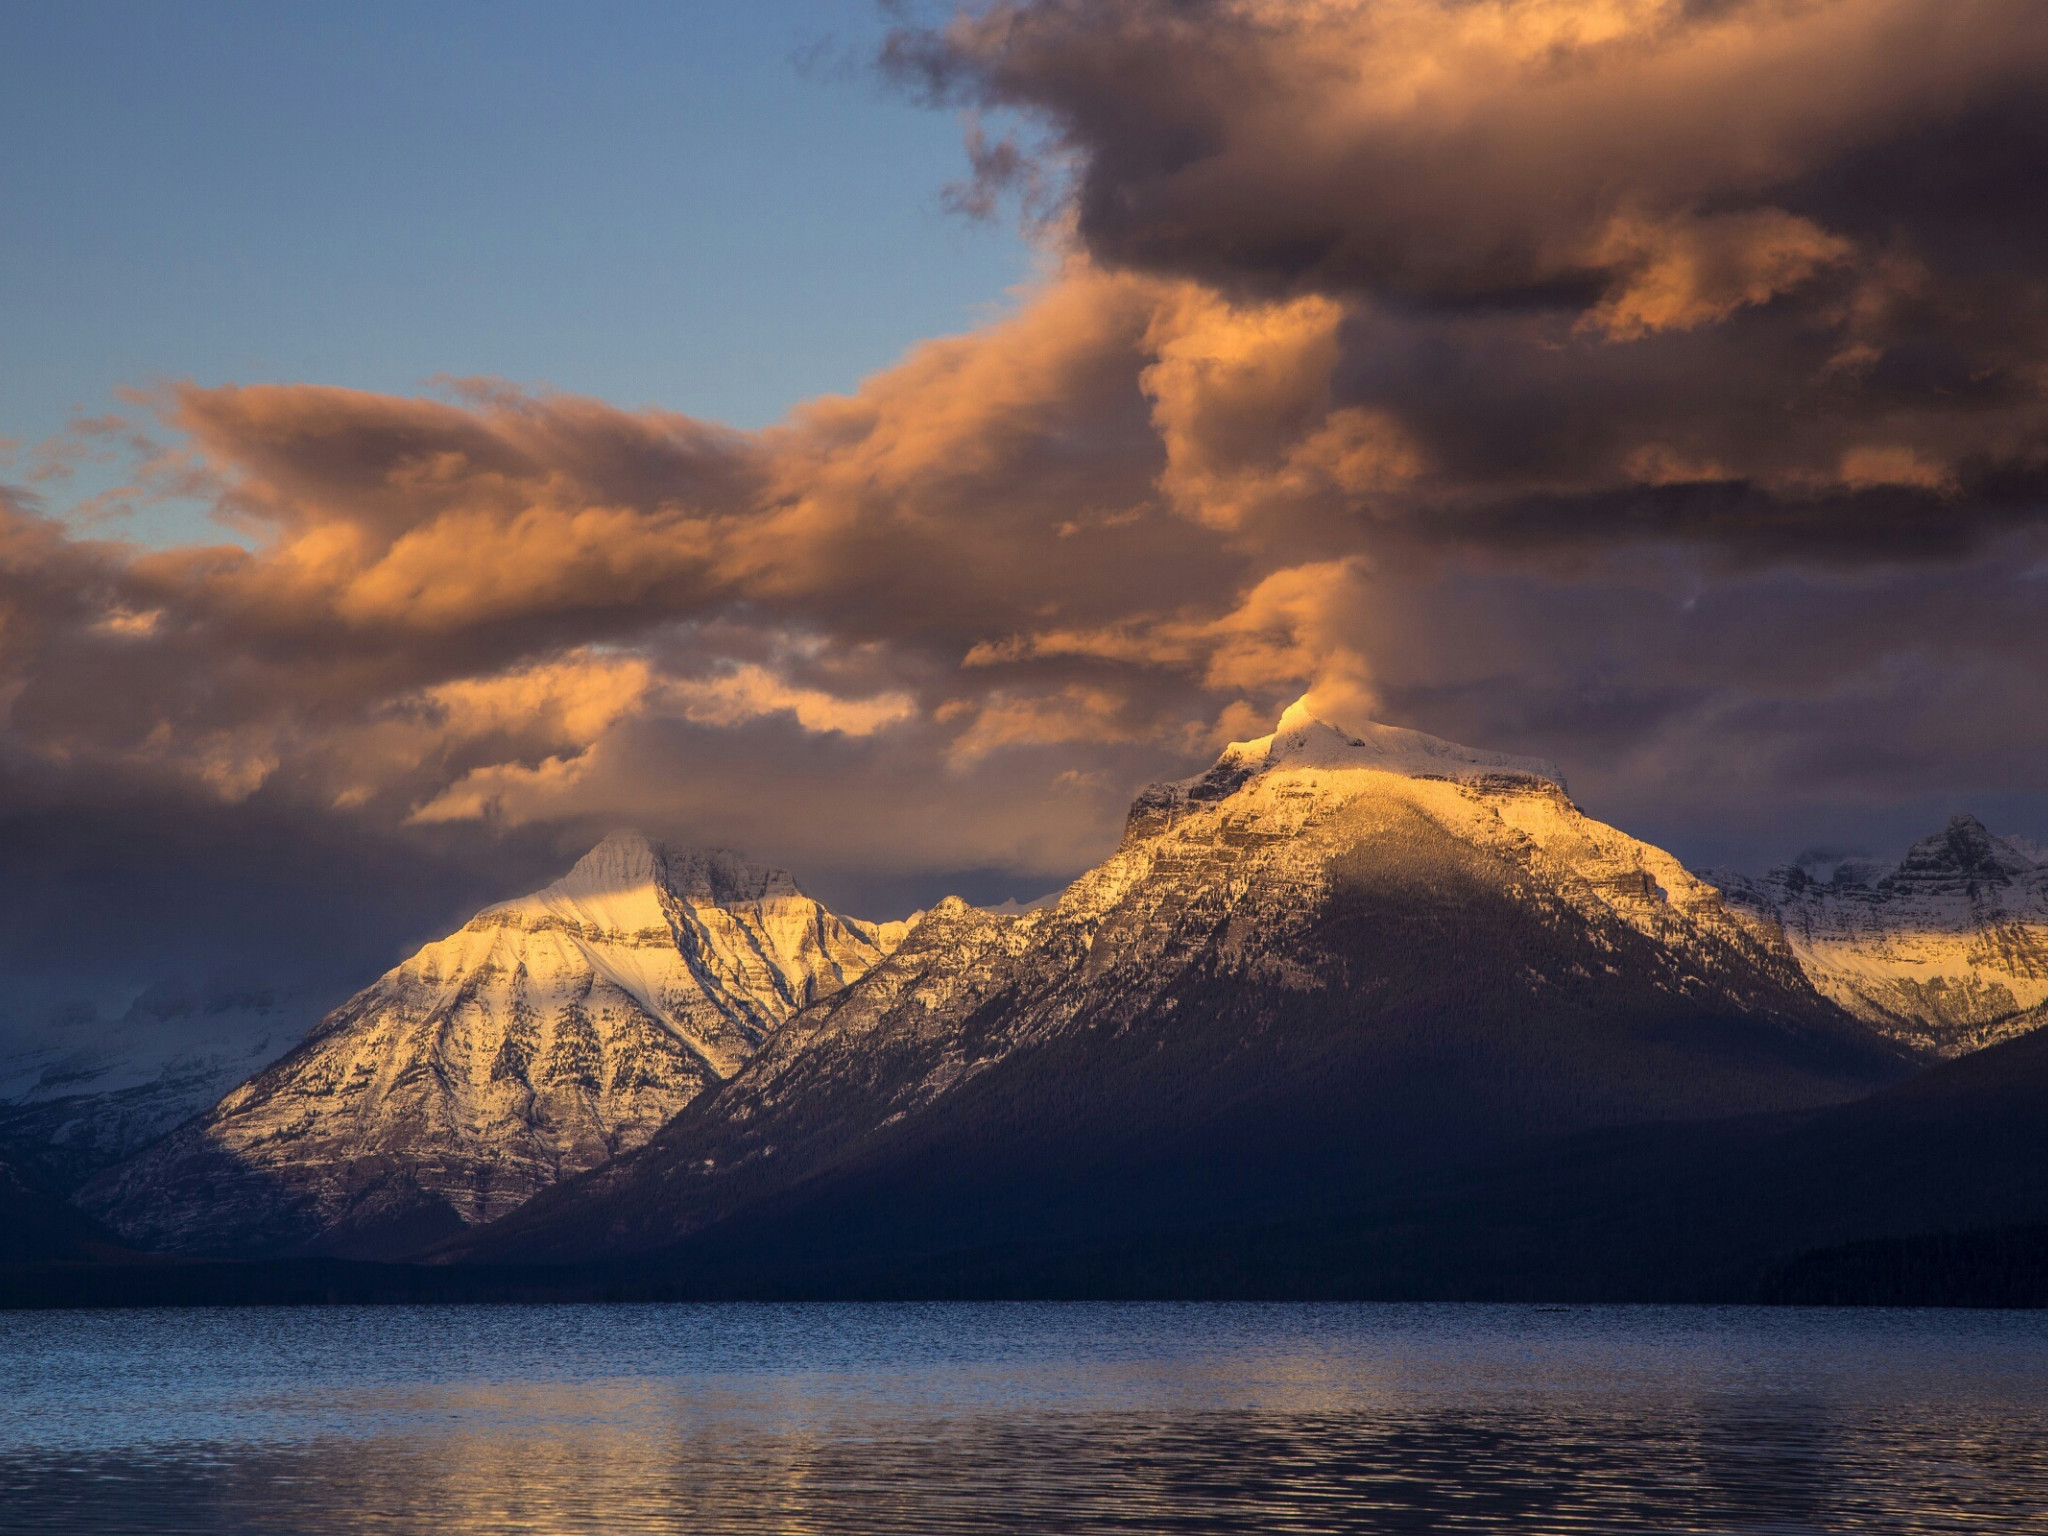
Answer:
0;0;2048;1003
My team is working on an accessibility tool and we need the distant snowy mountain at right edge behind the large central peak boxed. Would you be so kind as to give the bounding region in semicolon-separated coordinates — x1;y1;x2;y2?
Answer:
1708;815;2048;1057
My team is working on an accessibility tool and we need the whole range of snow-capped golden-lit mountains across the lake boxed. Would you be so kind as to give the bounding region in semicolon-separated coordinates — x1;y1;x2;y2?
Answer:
12;705;2048;1296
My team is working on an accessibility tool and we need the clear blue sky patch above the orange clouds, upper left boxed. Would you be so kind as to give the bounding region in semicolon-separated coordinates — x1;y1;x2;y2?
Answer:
0;0;1030;539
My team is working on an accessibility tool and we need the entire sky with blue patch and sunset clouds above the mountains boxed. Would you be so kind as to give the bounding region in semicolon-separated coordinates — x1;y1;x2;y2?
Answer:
0;0;2048;1028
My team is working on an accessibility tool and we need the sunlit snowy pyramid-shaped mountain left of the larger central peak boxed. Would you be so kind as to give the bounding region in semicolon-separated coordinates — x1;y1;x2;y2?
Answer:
78;834;903;1255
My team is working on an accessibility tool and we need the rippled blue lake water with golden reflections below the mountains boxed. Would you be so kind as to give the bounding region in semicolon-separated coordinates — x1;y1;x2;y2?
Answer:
0;1305;2048;1536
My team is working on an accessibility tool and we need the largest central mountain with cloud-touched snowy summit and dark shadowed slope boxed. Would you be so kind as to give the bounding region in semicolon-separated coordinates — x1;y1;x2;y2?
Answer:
440;705;1907;1268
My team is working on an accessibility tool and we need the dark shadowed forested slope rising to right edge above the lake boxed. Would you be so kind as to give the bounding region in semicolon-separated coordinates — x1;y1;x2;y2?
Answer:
1171;1011;2048;1305
